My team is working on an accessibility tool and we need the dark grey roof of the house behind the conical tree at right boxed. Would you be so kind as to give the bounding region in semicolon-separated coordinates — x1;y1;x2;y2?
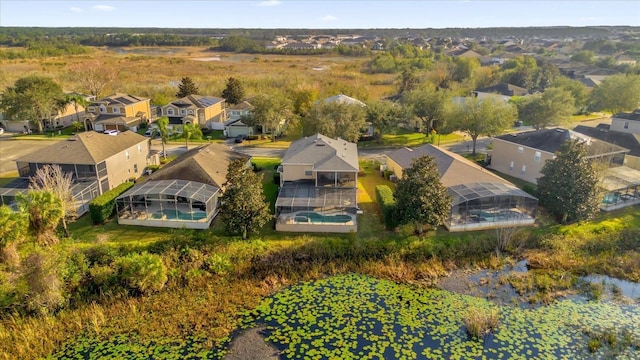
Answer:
495;128;628;156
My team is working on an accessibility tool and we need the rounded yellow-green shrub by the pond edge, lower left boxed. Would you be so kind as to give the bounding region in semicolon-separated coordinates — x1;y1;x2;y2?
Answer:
115;253;167;294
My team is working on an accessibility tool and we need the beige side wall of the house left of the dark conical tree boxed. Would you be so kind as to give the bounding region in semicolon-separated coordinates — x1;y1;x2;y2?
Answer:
491;139;553;184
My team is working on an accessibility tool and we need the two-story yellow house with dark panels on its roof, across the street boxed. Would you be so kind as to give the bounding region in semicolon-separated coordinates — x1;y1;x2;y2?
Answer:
158;95;227;132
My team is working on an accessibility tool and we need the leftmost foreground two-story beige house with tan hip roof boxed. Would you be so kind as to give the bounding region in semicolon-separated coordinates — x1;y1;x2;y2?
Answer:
0;131;149;215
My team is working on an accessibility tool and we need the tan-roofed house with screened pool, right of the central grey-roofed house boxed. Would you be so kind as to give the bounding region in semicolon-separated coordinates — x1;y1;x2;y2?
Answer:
386;144;538;231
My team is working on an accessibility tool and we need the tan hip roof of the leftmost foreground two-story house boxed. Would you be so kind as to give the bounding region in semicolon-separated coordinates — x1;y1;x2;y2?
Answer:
16;131;149;165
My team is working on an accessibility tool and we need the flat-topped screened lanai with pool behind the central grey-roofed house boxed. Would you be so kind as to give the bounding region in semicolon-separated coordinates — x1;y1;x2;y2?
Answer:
276;181;357;232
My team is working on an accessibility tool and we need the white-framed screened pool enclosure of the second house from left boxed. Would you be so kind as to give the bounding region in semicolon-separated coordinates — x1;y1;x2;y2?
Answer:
116;180;220;229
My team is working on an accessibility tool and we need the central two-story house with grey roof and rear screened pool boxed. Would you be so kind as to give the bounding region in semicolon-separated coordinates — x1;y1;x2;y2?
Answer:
276;134;359;232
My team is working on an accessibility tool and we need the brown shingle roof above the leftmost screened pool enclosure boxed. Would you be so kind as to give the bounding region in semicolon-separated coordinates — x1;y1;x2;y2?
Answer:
149;143;249;188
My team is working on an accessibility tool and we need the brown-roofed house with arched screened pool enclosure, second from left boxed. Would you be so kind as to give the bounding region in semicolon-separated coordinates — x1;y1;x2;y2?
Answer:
116;143;250;229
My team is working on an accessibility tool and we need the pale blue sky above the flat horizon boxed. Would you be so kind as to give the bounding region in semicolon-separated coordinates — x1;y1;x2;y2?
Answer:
0;0;640;29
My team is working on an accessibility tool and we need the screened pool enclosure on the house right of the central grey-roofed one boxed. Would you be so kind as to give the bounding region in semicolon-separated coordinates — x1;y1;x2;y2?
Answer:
445;182;538;231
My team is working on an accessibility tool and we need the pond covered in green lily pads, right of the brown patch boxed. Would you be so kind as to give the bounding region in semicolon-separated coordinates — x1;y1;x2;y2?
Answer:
236;274;640;359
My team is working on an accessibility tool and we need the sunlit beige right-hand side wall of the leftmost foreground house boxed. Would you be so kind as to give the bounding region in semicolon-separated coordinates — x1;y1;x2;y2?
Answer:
106;140;149;189
